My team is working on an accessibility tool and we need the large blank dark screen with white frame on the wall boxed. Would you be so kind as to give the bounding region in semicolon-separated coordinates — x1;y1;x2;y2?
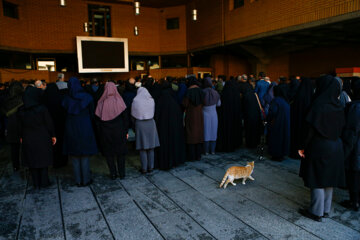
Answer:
76;36;129;73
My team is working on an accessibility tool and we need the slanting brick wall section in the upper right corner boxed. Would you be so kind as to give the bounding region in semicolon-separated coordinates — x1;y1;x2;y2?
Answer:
225;0;360;41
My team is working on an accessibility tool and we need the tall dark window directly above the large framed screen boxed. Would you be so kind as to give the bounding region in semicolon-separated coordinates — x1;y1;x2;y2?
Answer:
88;5;111;37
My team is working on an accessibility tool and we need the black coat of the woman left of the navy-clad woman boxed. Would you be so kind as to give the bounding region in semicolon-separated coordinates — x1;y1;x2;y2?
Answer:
19;106;55;168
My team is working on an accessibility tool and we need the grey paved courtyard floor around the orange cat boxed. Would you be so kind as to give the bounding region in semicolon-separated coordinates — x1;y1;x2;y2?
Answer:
0;146;360;240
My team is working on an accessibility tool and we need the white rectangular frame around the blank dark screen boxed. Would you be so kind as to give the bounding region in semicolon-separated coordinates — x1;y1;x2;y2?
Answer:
76;36;129;73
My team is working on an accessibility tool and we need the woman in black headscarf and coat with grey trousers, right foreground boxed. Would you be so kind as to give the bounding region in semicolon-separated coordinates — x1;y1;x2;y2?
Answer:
299;75;345;221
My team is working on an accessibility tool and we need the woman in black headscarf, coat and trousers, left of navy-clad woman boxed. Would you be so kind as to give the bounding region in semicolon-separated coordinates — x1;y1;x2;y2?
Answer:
19;87;56;188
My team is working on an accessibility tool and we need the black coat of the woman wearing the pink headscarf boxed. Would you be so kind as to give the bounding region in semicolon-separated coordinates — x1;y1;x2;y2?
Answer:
96;109;129;157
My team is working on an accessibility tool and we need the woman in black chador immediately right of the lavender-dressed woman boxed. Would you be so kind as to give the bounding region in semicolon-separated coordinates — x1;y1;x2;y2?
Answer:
217;80;243;152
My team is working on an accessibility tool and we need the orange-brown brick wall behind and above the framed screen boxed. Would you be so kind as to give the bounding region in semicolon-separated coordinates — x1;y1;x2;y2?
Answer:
0;0;186;53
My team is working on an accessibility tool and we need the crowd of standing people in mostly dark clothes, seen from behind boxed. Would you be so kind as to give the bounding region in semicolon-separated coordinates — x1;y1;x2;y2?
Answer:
0;73;360;221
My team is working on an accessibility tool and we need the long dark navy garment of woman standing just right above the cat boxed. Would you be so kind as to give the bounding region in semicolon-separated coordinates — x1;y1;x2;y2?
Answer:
267;97;290;158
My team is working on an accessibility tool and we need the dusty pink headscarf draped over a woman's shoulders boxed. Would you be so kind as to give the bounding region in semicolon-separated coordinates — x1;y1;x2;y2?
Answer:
95;82;126;121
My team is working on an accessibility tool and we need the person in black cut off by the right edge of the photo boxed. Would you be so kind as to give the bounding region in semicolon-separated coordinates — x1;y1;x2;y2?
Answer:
341;79;360;211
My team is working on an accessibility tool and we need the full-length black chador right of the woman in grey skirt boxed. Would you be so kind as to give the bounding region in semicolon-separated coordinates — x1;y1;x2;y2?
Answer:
155;88;185;170
